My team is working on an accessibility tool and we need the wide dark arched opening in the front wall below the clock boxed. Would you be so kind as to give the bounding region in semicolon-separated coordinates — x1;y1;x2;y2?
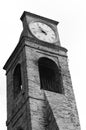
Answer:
38;57;63;93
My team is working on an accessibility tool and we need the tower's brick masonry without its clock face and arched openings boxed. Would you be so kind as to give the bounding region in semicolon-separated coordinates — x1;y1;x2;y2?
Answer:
4;11;80;130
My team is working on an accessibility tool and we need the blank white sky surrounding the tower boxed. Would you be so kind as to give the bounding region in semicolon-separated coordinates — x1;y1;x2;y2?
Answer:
0;0;86;130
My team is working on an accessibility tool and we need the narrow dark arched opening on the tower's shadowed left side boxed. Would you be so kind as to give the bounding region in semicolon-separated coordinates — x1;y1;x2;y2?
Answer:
13;64;22;98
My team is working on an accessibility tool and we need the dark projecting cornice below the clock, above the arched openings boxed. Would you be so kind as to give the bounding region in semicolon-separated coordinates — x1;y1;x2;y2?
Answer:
3;36;67;70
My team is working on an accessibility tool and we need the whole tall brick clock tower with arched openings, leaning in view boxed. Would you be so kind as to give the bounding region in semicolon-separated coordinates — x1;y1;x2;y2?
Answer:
4;12;80;130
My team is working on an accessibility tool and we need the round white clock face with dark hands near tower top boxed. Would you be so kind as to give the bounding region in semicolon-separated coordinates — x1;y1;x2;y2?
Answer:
29;22;56;43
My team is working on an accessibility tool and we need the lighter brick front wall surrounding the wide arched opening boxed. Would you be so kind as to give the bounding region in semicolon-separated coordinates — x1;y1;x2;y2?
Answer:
26;43;80;130
